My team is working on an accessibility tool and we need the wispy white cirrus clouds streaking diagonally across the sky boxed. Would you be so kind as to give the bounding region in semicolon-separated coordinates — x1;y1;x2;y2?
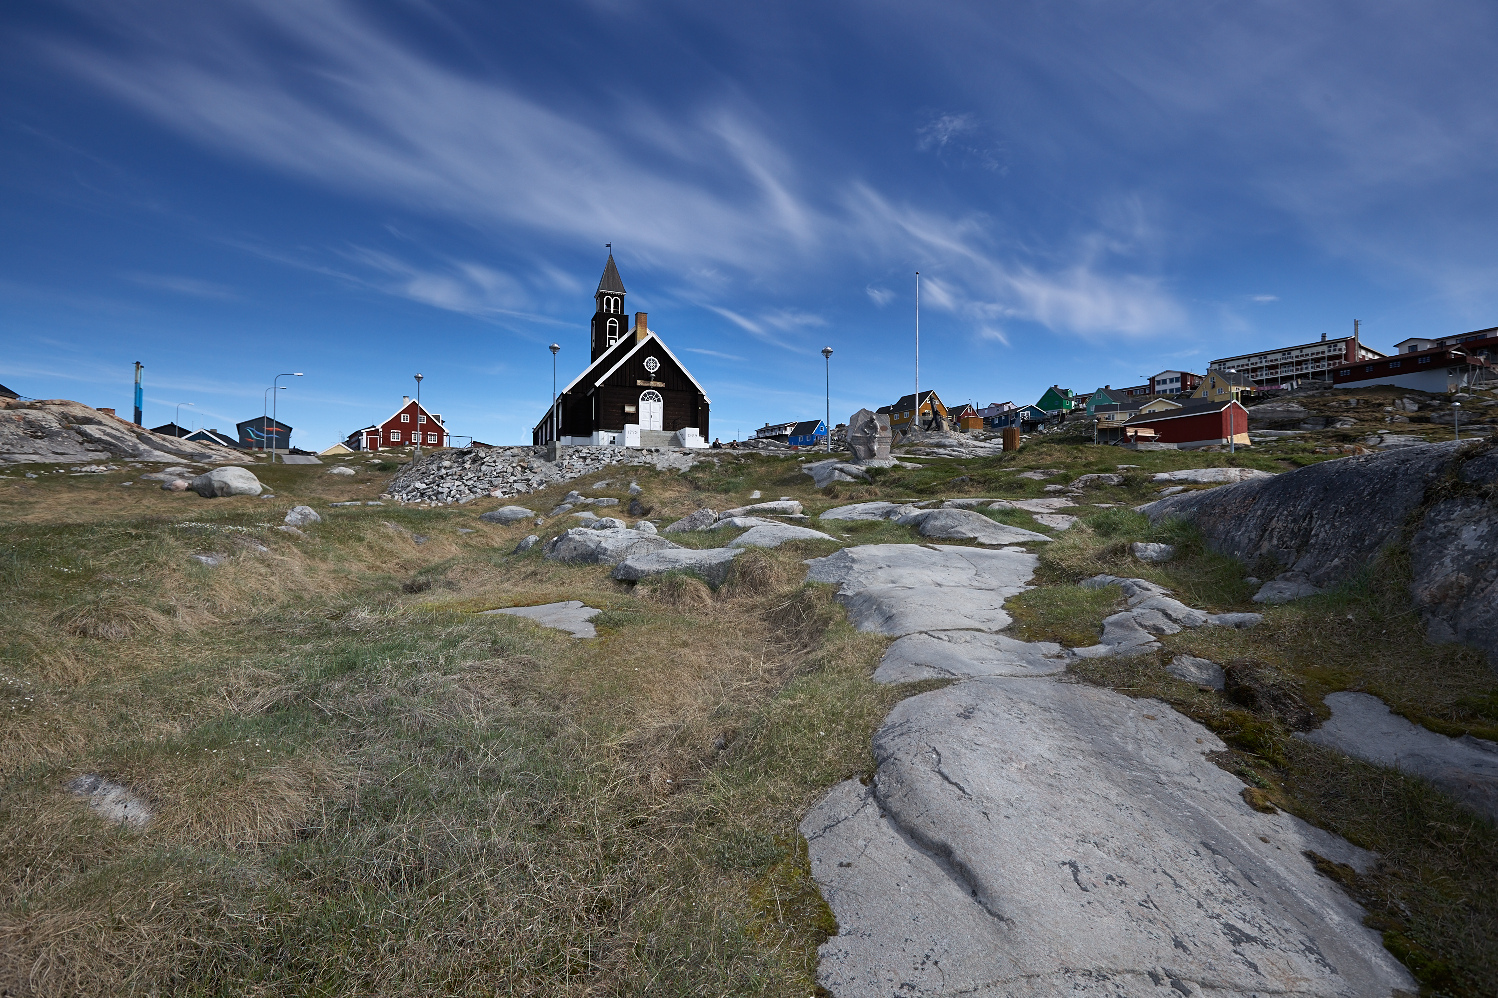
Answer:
41;0;1180;346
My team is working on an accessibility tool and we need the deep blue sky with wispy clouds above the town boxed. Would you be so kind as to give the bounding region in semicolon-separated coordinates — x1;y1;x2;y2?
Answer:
0;0;1498;448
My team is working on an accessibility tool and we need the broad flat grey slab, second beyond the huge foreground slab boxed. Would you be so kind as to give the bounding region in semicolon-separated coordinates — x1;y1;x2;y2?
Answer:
806;544;1040;637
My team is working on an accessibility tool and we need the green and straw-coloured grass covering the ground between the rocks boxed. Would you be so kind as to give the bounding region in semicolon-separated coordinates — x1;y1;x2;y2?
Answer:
0;428;1498;995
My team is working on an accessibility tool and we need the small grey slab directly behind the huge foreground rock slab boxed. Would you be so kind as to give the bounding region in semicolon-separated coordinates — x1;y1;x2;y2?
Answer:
873;631;1068;683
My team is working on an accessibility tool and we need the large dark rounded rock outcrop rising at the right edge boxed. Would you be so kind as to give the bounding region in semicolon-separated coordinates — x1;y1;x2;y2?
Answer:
1140;441;1498;667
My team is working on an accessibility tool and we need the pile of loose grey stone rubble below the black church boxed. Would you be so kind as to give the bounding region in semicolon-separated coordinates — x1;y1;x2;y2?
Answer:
386;447;703;505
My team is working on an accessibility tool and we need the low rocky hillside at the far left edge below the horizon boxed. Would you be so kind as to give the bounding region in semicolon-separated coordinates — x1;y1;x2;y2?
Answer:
0;399;244;465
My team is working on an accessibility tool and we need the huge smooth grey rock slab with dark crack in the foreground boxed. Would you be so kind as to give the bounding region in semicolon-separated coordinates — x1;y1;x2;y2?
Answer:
800;679;1417;998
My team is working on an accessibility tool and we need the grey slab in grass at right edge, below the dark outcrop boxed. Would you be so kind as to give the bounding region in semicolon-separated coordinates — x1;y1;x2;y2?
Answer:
1296;692;1498;821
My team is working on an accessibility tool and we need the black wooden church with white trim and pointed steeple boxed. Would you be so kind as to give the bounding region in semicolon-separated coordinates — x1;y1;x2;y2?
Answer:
532;253;709;447
